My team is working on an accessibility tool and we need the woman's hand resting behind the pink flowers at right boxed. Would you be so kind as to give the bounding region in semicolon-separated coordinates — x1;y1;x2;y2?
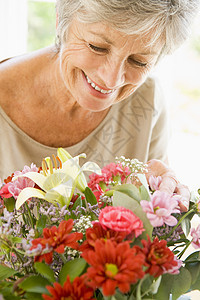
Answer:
146;159;190;211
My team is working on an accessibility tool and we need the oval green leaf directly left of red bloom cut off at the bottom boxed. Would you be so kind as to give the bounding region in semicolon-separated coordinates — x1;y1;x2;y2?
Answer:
19;275;50;294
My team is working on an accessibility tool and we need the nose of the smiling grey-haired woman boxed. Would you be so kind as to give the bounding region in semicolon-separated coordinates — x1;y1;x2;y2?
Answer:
98;61;125;89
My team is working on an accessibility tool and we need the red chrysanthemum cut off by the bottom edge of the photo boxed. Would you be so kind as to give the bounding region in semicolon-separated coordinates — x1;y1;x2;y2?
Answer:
42;276;95;300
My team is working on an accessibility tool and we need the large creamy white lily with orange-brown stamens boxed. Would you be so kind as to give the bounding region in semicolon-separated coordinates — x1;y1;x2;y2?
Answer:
14;148;101;209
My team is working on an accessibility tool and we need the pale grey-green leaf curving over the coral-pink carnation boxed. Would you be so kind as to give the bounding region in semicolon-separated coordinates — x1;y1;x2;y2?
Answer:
113;191;153;238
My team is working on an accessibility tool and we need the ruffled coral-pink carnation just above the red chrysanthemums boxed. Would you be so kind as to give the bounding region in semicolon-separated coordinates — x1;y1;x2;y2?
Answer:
99;206;144;237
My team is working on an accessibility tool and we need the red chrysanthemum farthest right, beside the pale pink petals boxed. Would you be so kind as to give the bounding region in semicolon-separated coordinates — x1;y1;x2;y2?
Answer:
142;237;178;277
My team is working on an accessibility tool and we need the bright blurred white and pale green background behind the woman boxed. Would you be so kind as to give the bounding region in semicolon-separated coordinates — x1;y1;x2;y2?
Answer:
0;0;200;300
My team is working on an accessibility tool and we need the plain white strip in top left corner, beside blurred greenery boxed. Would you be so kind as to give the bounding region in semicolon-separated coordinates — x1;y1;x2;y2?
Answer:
0;0;28;60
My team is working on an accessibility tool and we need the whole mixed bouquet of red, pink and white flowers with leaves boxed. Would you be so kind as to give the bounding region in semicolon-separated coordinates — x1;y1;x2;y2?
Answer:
0;148;200;300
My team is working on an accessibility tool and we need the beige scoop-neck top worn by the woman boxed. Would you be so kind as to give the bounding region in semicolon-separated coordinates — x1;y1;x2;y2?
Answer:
0;78;168;179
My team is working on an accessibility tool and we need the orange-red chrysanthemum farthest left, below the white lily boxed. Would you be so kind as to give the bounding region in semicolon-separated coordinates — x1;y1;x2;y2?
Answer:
30;219;83;264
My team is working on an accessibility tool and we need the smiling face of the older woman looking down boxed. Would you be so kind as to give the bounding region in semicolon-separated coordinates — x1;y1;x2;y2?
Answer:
60;20;162;111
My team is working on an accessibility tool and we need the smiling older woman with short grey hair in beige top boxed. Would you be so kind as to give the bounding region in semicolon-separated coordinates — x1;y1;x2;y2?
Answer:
0;0;199;209
